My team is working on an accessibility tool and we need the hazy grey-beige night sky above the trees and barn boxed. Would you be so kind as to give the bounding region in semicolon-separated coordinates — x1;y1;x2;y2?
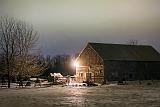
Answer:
0;0;160;55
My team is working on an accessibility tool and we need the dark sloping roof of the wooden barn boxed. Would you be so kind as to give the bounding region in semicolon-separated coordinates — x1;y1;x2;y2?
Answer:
88;43;160;61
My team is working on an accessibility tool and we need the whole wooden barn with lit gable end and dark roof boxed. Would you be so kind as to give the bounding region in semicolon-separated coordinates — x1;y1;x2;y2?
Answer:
76;43;160;83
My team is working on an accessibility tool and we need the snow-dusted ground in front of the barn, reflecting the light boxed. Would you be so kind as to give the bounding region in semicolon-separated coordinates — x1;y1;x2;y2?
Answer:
0;85;160;107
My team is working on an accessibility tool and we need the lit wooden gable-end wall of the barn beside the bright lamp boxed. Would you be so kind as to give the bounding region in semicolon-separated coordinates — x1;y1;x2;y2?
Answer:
76;45;104;83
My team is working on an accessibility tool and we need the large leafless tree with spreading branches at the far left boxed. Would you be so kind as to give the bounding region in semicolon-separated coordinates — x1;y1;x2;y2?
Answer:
0;17;42;88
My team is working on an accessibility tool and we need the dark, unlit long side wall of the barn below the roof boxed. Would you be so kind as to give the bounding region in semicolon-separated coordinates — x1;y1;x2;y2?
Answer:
104;61;160;81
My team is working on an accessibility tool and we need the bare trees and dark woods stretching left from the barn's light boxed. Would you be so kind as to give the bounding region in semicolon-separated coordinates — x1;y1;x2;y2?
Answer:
0;16;74;88
